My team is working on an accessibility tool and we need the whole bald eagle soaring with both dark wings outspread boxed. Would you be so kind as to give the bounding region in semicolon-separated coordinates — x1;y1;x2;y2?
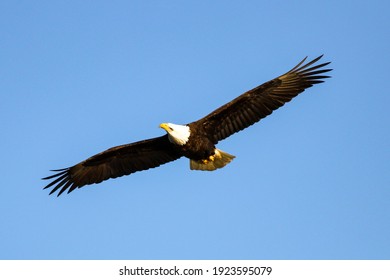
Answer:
43;56;332;196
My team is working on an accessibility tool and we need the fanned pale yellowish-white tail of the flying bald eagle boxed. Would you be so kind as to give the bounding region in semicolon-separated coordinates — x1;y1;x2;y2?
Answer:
190;149;235;171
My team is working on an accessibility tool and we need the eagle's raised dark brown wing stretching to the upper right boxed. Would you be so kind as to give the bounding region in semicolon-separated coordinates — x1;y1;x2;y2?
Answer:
196;56;331;144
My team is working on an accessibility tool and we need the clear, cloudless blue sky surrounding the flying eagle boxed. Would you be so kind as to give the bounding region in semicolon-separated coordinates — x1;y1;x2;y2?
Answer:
0;1;390;259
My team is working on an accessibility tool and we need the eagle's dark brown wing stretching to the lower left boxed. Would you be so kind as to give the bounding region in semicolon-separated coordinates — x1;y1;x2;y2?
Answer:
43;135;181;196
